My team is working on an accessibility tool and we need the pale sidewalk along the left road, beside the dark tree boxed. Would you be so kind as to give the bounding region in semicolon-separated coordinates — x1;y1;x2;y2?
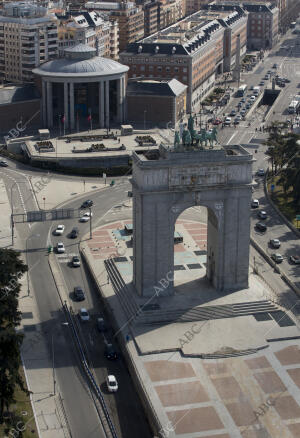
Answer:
0;180;70;438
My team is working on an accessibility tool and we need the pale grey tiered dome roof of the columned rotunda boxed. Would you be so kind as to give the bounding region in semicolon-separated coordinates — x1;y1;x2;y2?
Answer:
33;44;129;77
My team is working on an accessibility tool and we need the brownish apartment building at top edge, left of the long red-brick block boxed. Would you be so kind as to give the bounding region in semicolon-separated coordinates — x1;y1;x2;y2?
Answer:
85;2;144;51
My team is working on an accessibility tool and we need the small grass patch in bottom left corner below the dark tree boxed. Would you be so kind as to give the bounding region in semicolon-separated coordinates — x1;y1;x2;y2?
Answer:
0;367;38;438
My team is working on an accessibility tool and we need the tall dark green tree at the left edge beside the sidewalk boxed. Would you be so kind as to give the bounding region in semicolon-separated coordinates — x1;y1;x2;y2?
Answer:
0;249;28;424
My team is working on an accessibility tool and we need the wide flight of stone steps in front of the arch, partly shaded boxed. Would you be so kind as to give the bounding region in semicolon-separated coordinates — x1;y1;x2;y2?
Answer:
138;300;278;325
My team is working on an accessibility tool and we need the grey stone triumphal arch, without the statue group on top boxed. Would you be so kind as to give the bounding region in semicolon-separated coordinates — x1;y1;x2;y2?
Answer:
132;140;253;297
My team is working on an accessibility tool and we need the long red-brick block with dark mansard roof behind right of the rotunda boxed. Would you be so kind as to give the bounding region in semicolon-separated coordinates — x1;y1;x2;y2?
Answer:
120;8;247;112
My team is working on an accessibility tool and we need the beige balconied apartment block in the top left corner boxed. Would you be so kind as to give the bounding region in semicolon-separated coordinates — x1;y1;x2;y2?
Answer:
0;2;58;82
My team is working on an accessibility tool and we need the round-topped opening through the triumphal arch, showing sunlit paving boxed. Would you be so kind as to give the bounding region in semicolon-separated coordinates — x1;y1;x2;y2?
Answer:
174;206;219;301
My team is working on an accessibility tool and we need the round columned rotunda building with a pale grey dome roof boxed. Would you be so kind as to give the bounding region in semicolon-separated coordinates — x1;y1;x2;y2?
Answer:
33;44;129;129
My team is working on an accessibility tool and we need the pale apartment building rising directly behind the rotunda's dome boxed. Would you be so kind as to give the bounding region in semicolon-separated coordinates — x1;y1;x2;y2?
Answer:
58;11;119;59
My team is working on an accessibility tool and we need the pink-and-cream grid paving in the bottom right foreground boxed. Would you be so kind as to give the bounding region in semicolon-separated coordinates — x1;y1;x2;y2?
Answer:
144;341;300;438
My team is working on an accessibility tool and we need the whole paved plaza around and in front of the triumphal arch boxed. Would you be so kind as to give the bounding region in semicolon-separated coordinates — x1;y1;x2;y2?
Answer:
82;219;300;438
